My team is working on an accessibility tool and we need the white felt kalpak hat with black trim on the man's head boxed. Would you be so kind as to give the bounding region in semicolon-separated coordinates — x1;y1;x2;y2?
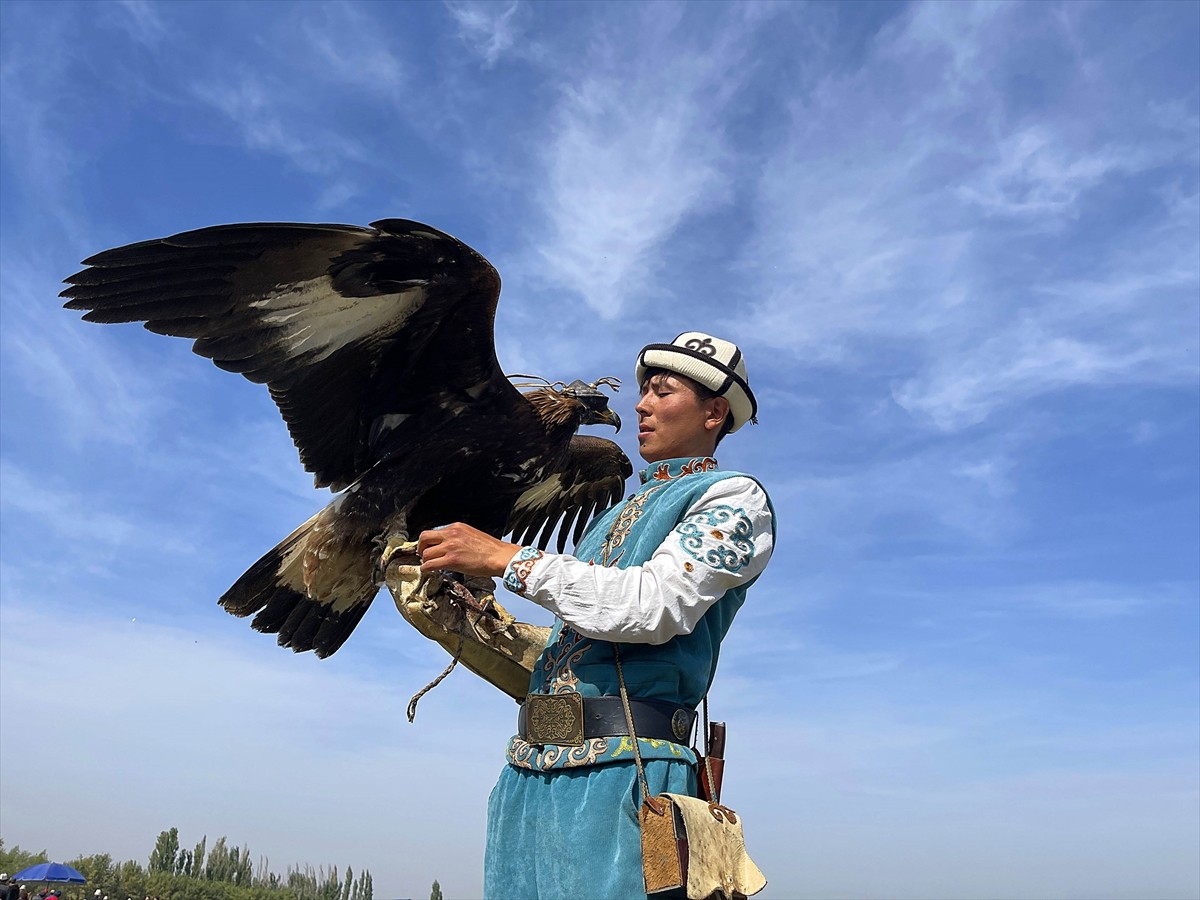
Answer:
637;331;758;433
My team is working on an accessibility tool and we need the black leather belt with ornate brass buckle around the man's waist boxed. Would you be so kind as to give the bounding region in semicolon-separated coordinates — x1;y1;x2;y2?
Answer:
517;694;696;746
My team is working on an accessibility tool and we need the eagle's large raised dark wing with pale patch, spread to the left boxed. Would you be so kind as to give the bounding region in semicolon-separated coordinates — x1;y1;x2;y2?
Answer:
61;218;511;490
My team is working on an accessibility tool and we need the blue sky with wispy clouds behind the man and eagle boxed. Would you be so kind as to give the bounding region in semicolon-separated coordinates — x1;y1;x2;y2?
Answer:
0;0;1200;898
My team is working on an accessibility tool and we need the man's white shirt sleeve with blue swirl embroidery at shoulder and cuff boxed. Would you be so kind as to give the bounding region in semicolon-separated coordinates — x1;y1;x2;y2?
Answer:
504;476;775;643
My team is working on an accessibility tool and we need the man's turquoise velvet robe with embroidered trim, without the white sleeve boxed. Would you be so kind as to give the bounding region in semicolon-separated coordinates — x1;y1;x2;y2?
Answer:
484;457;772;900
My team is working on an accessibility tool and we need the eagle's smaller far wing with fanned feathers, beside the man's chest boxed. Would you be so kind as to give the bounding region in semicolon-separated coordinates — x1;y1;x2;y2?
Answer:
508;434;634;553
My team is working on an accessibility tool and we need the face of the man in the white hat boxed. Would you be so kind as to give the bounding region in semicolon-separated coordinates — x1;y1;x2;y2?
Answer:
634;373;727;462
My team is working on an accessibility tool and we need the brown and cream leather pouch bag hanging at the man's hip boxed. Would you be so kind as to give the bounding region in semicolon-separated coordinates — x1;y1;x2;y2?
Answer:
641;793;767;900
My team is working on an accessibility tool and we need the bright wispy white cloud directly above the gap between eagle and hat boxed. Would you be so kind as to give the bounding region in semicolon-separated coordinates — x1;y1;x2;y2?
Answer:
525;5;752;318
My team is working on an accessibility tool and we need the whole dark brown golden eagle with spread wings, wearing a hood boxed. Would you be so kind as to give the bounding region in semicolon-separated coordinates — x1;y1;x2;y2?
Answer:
61;218;632;656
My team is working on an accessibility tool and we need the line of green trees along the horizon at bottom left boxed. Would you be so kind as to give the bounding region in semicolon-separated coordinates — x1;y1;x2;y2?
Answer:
0;828;374;900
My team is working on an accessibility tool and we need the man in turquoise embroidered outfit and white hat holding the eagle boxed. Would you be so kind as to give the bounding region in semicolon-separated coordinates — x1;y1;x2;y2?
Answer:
418;332;774;898
